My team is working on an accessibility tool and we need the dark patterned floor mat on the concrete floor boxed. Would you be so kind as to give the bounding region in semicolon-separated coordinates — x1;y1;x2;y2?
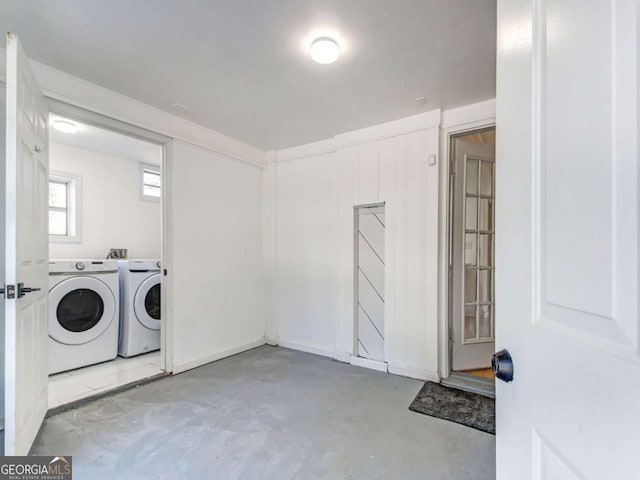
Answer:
409;382;496;435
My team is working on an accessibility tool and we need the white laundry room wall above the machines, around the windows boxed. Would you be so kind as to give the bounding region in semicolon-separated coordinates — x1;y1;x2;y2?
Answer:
49;142;162;258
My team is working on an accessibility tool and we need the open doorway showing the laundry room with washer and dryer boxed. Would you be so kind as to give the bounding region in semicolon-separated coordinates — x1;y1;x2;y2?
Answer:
48;113;165;409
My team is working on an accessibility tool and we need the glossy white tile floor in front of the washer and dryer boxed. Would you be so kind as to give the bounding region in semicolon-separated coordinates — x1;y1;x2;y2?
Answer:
49;352;163;408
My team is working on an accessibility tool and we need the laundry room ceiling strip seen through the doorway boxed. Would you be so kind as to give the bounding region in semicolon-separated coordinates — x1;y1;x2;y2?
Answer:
49;115;162;165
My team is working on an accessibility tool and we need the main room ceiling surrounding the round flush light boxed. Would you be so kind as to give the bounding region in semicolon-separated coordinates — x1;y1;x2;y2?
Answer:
0;0;496;150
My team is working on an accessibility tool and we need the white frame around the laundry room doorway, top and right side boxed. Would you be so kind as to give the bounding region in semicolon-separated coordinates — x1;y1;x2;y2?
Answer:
45;99;174;373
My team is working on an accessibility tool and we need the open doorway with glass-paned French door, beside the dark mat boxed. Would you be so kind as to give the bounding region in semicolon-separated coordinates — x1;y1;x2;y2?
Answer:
443;127;496;395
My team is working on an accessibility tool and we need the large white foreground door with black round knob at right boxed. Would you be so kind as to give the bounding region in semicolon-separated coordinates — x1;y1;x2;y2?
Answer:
496;0;640;480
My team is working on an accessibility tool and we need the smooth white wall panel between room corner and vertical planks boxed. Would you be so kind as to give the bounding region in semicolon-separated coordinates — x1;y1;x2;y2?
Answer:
274;153;340;355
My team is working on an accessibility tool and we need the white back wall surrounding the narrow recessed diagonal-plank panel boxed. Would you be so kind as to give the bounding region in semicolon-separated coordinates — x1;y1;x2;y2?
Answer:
268;111;440;378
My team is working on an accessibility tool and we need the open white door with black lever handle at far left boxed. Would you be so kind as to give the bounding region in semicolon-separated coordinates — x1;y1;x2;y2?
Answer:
5;34;49;455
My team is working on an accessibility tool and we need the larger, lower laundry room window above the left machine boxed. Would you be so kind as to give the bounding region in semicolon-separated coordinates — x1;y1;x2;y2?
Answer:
49;174;80;241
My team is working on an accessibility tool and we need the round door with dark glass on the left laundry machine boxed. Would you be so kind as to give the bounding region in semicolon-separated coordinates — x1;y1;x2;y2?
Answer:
49;277;117;345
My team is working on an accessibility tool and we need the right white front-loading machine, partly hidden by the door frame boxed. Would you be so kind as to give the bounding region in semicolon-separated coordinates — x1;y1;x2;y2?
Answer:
118;260;161;357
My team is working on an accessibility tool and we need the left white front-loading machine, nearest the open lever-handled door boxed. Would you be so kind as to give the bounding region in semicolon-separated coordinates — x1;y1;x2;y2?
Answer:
49;260;120;374
